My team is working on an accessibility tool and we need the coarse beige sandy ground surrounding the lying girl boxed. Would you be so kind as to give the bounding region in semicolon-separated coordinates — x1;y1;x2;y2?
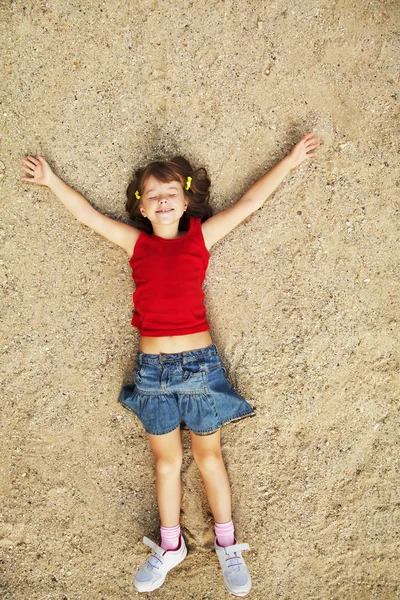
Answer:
0;0;400;600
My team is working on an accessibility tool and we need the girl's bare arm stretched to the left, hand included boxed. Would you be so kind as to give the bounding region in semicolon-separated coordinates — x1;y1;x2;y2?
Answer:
22;155;140;257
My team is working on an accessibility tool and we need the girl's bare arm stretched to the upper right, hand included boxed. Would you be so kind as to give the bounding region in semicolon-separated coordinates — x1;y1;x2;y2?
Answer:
201;133;319;250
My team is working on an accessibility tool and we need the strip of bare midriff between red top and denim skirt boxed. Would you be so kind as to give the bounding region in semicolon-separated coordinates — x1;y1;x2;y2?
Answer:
139;331;213;354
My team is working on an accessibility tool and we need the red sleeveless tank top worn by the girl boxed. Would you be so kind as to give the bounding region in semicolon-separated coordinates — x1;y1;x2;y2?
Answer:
129;217;210;337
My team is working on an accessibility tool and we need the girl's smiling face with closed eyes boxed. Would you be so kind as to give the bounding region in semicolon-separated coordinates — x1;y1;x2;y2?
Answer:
140;175;188;225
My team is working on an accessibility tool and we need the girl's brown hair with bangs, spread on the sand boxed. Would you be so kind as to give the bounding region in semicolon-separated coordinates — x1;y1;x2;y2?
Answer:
126;156;212;233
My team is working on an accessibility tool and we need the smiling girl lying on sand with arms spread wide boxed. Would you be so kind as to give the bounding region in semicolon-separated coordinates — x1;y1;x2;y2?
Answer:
22;133;319;597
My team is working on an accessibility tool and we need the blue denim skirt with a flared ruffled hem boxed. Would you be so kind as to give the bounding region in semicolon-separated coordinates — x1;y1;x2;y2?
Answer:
118;344;254;435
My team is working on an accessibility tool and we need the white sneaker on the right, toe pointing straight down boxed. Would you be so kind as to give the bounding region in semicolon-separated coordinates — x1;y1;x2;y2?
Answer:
214;538;251;598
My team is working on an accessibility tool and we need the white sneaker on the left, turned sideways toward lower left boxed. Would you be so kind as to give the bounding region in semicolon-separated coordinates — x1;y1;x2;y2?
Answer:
133;535;187;592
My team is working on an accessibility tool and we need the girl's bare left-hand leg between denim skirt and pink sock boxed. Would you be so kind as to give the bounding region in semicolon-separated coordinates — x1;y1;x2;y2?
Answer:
148;427;182;527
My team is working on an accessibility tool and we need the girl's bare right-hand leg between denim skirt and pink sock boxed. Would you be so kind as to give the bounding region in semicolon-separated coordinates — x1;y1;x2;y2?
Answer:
190;431;232;523
